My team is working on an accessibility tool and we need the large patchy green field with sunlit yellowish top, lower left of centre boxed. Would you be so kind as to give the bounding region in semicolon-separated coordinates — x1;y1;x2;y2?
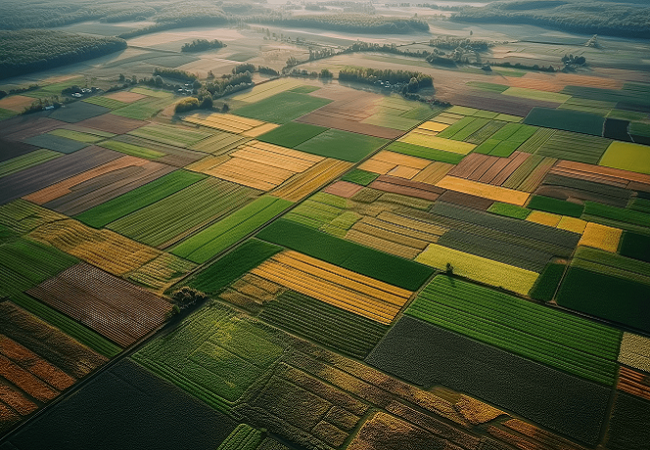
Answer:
132;304;285;413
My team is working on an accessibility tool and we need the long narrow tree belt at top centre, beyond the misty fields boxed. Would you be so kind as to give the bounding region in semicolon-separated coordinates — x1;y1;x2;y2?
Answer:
249;14;429;34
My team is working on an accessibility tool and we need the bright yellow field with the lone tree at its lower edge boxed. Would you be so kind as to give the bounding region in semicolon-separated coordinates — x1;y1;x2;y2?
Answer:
415;244;539;295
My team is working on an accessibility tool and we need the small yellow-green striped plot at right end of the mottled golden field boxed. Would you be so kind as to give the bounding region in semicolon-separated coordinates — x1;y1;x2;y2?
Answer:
128;253;196;295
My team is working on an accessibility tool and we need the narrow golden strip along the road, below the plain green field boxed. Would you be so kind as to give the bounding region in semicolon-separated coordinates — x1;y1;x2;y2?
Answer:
272;158;354;202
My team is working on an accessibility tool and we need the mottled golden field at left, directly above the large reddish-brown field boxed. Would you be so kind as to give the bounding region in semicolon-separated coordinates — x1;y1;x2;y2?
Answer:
29;219;162;276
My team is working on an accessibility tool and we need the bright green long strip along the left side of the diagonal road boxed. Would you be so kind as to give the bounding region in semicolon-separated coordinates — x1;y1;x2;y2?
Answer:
171;195;292;263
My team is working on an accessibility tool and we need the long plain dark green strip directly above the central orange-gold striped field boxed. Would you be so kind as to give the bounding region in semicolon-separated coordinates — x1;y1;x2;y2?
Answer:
257;219;433;291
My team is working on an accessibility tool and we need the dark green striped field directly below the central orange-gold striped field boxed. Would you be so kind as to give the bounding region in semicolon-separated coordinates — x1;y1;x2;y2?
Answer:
258;291;388;359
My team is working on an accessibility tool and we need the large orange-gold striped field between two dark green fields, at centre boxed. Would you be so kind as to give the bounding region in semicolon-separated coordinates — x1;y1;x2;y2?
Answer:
250;251;412;324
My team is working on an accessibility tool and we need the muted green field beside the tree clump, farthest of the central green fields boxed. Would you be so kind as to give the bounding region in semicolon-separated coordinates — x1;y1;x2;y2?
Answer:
234;92;332;124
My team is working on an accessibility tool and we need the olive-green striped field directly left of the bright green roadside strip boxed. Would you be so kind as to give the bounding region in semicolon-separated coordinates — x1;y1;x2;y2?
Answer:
108;178;255;247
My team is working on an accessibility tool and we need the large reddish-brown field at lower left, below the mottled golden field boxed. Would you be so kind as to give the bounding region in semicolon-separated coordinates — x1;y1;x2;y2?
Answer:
28;263;171;347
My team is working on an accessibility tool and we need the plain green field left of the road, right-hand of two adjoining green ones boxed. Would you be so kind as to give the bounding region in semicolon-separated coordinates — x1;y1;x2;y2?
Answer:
295;129;388;162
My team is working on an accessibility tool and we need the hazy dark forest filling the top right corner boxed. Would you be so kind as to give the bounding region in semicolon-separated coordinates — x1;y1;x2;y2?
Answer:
451;0;650;39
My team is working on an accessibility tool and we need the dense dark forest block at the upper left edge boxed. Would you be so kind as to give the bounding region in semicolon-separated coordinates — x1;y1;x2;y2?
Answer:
0;30;126;79
